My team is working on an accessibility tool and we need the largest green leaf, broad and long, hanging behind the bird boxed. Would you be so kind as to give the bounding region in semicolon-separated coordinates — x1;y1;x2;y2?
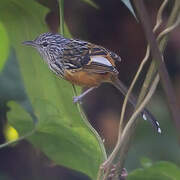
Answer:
0;0;105;179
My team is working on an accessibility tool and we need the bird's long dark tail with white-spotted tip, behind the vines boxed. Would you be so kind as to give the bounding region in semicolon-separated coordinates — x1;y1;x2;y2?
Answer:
112;78;161;133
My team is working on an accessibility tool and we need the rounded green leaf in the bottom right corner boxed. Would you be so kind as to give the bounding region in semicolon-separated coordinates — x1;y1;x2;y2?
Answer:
127;161;180;180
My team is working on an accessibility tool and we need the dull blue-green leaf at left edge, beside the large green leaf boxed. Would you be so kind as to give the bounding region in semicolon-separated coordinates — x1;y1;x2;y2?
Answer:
0;48;37;122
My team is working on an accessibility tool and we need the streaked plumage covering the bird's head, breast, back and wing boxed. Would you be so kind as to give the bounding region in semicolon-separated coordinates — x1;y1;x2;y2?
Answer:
27;33;121;78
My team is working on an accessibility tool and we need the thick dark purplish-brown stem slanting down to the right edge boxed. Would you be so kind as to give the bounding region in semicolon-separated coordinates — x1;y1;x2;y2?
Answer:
134;0;180;131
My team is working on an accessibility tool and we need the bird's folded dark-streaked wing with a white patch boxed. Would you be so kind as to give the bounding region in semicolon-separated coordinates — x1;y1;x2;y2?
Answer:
63;40;121;73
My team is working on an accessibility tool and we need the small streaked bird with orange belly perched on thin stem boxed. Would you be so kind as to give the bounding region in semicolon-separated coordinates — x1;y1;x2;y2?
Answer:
23;32;161;133
